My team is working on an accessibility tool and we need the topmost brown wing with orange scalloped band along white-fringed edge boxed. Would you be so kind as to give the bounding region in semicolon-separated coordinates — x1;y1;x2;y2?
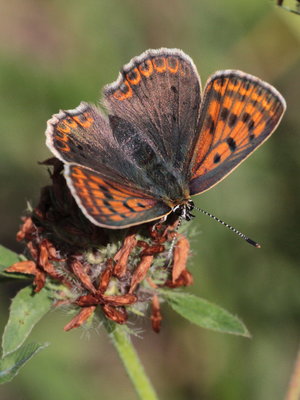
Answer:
104;49;200;171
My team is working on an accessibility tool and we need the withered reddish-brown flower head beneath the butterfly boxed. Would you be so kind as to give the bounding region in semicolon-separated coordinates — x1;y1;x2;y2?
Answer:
7;158;192;332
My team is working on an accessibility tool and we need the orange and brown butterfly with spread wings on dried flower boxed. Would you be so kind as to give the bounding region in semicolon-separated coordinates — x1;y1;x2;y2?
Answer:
46;48;286;233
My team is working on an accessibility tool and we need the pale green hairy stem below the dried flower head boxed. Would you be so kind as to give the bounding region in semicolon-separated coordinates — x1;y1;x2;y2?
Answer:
104;321;158;400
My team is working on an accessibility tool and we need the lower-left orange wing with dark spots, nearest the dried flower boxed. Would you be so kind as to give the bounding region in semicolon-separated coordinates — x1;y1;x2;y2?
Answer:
65;164;171;229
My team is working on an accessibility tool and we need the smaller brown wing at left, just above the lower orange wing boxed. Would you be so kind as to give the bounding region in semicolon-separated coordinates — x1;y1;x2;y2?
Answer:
46;103;158;192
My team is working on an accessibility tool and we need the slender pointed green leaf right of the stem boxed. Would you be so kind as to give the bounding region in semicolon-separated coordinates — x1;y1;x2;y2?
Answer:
160;290;250;337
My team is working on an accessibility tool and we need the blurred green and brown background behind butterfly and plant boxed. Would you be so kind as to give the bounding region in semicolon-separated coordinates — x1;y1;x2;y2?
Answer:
0;0;300;400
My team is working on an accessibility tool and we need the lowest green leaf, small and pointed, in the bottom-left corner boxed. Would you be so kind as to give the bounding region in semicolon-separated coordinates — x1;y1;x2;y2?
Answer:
0;343;49;383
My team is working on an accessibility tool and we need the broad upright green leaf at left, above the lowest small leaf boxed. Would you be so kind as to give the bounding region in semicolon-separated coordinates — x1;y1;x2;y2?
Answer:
2;286;52;356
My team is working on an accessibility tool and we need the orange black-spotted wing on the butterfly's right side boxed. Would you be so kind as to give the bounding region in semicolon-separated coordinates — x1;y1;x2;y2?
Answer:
189;70;286;195
